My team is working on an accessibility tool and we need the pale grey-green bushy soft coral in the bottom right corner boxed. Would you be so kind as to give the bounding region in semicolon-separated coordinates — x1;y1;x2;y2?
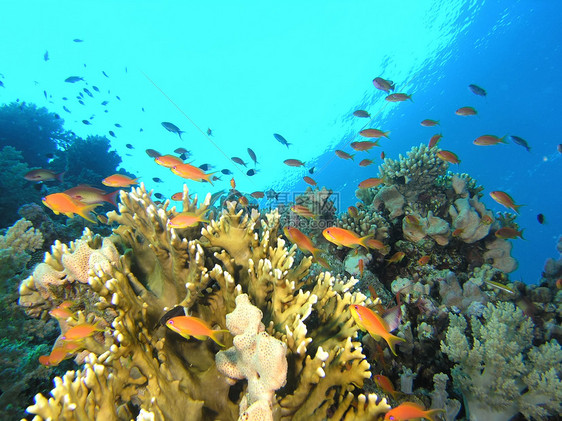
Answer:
441;302;562;420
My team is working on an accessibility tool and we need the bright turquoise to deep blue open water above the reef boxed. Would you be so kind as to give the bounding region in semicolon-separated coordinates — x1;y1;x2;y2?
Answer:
0;0;562;283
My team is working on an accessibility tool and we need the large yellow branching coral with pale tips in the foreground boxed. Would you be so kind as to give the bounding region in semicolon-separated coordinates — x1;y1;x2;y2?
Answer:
20;185;388;420
